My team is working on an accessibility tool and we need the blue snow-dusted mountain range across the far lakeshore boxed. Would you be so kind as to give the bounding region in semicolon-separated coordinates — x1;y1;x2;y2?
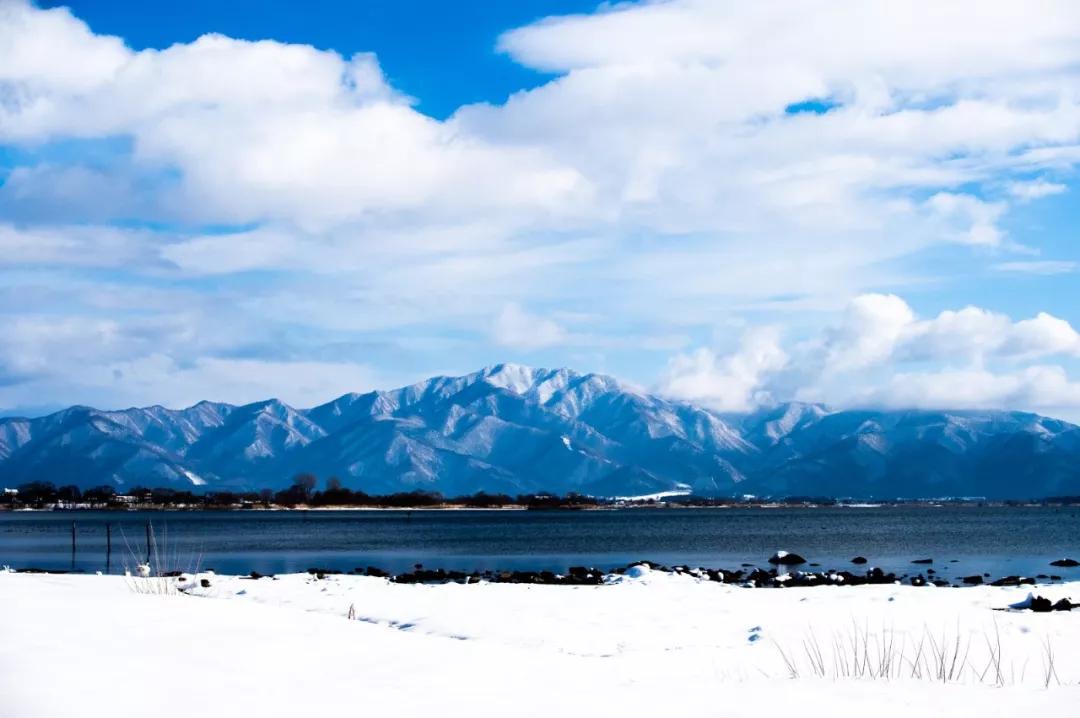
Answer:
0;364;1080;498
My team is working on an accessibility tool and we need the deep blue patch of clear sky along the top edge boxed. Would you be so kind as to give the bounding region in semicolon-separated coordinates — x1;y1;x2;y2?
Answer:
41;0;597;119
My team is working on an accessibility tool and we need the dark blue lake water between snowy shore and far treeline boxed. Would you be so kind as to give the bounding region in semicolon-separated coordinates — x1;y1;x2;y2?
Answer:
0;506;1080;580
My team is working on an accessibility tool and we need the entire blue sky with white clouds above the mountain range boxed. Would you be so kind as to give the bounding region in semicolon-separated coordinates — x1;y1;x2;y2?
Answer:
0;0;1080;420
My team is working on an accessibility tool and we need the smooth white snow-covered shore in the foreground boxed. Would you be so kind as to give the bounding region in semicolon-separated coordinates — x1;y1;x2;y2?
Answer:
0;570;1080;718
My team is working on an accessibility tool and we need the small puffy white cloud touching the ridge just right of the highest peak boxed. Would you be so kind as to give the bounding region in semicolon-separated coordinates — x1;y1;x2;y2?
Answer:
660;327;787;411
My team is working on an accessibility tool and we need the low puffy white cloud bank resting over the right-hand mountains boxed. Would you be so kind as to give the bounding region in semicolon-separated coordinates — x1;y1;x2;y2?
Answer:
660;295;1080;414
